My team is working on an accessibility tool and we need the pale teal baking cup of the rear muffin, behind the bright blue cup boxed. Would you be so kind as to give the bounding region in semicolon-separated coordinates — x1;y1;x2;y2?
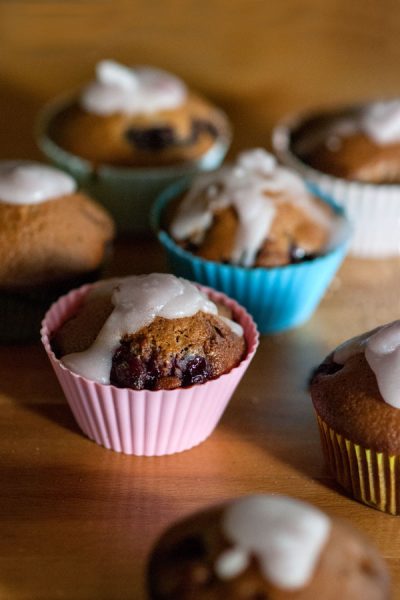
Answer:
36;96;231;234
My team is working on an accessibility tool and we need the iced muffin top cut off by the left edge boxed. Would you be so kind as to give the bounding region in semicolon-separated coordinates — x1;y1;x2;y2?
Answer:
0;161;114;288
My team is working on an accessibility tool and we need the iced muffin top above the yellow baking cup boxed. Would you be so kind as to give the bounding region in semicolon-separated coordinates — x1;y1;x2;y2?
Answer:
311;321;400;454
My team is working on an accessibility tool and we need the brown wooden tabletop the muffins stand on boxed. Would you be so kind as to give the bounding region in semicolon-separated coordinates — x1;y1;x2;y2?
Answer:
0;241;400;600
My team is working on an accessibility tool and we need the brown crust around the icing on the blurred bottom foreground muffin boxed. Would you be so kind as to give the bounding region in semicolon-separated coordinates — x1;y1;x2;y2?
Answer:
147;507;389;600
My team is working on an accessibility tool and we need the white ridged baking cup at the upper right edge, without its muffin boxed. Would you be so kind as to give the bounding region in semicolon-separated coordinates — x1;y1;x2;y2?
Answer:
273;116;400;258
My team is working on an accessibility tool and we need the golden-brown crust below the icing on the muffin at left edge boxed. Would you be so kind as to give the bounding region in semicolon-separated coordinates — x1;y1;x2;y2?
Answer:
0;193;114;289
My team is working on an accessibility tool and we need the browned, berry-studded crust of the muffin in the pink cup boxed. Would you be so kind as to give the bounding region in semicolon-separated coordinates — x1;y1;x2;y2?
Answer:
52;290;245;390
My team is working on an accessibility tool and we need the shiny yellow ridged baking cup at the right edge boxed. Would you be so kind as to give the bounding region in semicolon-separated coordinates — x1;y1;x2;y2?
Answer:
317;415;400;515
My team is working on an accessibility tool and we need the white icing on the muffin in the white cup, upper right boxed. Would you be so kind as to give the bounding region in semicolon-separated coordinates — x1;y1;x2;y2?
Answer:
361;100;400;145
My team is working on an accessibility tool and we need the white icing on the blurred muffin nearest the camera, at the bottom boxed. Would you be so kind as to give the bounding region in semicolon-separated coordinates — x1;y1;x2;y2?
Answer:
215;495;331;590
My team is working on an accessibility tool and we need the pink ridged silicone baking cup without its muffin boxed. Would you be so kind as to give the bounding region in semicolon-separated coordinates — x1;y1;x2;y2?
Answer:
41;285;259;456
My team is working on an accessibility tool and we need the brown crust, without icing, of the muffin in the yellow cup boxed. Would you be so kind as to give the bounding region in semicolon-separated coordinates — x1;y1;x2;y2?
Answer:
311;353;400;455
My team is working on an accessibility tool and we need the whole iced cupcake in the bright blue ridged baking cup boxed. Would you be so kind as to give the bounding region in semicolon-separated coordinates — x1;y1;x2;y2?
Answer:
153;149;349;333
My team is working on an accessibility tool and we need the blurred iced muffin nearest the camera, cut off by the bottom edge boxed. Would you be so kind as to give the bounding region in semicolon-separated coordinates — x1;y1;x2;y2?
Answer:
147;495;389;600
